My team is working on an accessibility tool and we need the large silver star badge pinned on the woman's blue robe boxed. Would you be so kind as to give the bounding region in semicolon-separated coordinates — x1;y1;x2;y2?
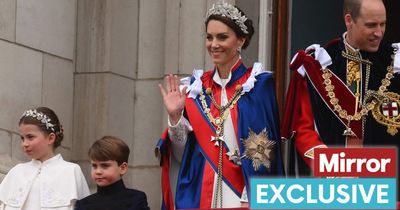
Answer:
242;128;276;171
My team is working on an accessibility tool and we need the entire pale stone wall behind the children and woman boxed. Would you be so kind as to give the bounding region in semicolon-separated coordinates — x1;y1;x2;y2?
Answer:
0;0;257;209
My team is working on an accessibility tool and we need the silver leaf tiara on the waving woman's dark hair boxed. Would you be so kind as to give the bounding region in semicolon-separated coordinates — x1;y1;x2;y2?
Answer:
206;2;249;34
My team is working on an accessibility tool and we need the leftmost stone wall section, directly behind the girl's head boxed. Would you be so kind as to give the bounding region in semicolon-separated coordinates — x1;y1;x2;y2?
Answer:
0;0;77;179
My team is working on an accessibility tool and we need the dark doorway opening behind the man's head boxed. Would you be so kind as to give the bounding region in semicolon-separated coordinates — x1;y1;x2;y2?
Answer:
290;0;400;56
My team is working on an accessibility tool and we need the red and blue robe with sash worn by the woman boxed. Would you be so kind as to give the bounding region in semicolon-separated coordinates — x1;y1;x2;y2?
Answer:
157;61;284;210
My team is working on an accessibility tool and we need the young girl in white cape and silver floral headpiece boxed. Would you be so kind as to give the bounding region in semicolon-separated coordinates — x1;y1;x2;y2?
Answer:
0;107;89;210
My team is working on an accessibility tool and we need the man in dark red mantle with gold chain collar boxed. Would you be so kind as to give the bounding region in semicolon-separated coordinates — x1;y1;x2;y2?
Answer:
282;0;400;174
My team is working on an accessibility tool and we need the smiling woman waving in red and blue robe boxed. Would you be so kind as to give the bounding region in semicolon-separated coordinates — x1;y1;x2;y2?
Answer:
158;3;283;209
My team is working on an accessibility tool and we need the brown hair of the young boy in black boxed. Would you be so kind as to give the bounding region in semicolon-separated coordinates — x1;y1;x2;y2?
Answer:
88;136;130;165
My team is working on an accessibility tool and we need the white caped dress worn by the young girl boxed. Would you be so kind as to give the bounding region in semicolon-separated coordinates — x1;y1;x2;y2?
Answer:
0;154;90;210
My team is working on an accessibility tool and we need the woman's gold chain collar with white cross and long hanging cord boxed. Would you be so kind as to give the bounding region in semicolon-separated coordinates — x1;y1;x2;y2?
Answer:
199;85;243;208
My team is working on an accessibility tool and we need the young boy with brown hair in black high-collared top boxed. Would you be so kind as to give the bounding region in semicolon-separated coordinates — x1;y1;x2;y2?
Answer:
75;136;149;210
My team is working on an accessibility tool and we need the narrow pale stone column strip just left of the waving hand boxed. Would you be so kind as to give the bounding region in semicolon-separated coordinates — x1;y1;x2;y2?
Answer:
128;0;166;209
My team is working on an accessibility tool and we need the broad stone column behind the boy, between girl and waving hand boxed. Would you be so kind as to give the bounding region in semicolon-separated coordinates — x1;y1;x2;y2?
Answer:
73;0;165;209
